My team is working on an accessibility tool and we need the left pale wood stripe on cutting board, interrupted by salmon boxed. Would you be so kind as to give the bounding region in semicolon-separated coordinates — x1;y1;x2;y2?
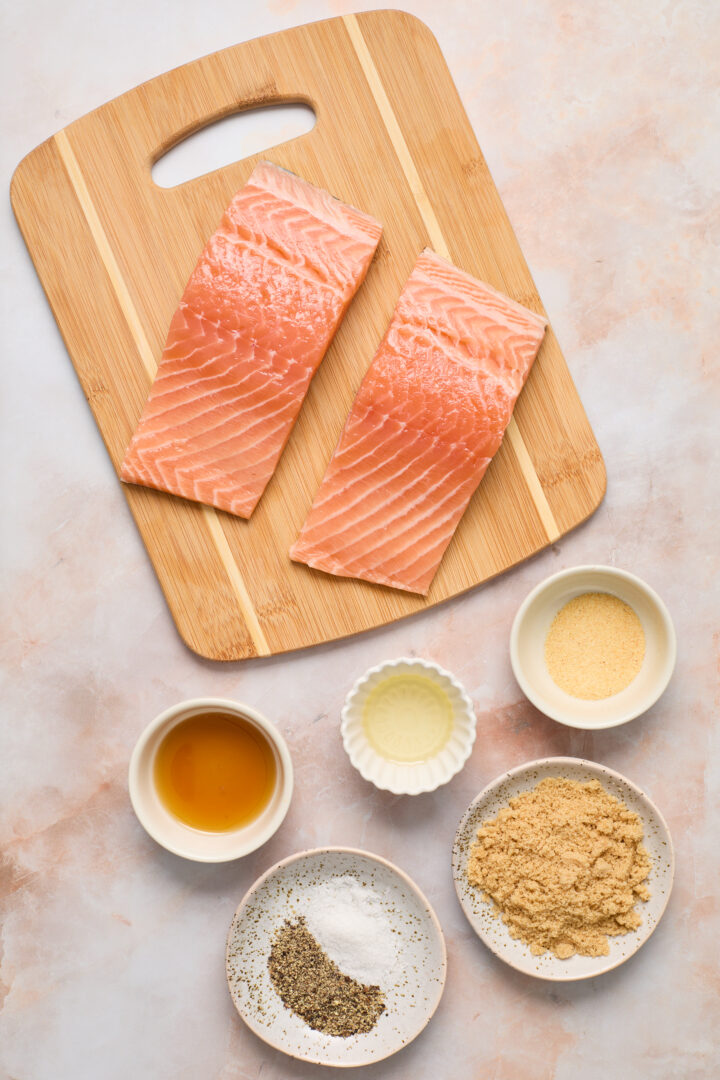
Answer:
54;131;271;657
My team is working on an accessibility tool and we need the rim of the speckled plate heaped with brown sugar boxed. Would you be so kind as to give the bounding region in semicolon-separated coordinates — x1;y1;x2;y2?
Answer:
450;756;675;983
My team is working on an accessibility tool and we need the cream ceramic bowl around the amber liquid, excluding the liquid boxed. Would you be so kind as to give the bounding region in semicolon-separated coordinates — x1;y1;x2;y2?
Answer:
128;698;293;863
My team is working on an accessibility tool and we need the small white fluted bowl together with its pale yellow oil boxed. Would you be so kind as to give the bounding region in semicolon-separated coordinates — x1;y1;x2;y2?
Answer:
340;657;475;795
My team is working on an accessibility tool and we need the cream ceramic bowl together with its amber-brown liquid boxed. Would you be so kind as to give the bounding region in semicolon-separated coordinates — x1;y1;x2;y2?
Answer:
128;698;293;863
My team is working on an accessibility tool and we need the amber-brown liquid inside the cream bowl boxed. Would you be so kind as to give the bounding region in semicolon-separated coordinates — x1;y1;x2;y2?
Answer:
154;713;277;833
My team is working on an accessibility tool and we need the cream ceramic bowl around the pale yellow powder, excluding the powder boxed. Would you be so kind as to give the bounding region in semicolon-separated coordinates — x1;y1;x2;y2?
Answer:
510;566;676;730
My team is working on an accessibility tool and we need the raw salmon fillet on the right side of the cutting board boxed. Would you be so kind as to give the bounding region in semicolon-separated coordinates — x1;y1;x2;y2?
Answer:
290;251;545;595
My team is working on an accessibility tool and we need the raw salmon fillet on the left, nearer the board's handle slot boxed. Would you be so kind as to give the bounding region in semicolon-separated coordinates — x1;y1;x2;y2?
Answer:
120;162;382;517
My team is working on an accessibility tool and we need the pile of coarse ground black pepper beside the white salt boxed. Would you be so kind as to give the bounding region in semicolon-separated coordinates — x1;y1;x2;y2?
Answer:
268;917;385;1038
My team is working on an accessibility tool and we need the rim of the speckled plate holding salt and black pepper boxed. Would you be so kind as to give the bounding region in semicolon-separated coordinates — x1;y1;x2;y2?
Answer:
225;845;448;1069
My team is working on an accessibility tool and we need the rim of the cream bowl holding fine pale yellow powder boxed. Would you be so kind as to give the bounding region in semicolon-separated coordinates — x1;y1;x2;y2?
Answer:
510;563;677;731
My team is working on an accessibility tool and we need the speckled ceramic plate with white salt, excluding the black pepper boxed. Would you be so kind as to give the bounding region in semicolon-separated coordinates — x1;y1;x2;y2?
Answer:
226;848;447;1066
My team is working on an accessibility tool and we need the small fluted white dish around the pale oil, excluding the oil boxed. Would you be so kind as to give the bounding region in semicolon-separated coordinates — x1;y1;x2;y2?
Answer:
340;657;475;795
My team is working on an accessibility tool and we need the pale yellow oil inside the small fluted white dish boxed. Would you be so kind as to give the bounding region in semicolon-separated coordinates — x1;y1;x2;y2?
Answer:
363;674;452;765
